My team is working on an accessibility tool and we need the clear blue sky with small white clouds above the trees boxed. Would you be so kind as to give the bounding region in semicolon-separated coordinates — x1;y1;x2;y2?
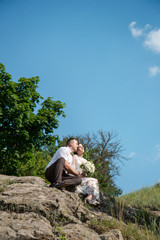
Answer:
0;0;160;193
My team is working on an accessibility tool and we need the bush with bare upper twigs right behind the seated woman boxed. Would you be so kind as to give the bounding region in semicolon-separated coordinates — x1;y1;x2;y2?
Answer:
60;130;126;196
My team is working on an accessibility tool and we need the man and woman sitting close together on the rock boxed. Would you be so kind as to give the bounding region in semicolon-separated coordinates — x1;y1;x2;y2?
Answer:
45;138;99;205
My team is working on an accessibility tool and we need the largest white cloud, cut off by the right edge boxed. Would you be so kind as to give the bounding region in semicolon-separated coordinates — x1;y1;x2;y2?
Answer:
144;28;160;53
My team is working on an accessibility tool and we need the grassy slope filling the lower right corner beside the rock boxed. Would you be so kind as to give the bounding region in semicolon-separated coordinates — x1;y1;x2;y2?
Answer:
91;184;160;240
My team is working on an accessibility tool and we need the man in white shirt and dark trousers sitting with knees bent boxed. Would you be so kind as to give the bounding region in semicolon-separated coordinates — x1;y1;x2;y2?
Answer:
45;138;82;189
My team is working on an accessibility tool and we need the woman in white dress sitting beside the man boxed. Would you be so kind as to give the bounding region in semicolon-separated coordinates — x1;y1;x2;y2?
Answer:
71;144;100;205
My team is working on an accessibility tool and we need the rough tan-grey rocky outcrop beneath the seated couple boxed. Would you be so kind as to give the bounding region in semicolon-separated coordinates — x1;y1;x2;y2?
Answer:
0;175;123;240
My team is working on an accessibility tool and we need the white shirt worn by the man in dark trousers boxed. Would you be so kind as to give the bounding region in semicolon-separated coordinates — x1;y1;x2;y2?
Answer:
45;147;72;170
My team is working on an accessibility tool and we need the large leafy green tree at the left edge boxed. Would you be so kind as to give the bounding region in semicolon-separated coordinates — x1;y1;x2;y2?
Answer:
0;64;65;175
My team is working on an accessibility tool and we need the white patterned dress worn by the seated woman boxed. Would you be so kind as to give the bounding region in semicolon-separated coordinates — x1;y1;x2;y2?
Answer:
71;155;99;201
